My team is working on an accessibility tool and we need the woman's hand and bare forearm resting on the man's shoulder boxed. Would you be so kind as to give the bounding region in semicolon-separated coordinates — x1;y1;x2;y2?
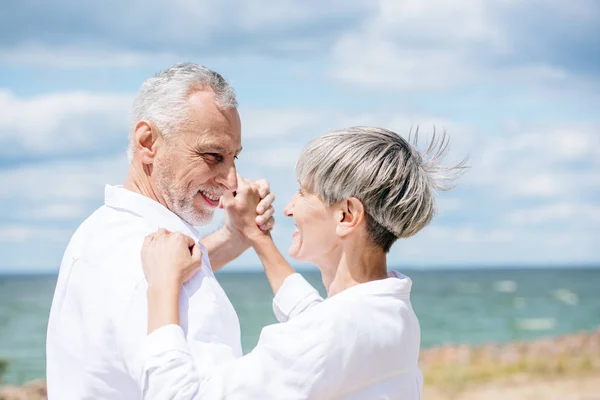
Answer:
142;229;202;334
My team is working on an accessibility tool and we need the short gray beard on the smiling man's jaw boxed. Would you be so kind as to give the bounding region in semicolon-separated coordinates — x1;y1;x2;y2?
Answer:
155;167;222;226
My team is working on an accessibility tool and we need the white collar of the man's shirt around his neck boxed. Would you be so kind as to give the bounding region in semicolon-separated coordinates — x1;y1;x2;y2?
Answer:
104;185;200;240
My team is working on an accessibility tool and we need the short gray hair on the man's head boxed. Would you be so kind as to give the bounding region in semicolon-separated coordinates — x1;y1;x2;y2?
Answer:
127;63;237;161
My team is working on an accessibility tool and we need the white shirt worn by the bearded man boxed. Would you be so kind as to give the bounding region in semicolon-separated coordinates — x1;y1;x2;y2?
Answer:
46;186;248;400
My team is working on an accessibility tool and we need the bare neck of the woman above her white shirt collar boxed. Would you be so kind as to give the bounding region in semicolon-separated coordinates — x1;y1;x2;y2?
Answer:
321;246;387;297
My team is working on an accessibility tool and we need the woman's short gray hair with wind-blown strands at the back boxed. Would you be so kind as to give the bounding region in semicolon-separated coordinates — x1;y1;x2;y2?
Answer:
296;126;466;252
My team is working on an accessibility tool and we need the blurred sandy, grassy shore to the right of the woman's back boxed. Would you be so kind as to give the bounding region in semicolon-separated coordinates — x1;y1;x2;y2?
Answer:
421;328;600;400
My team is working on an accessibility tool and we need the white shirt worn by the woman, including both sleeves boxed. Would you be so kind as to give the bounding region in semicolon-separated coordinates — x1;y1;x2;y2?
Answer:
144;272;423;400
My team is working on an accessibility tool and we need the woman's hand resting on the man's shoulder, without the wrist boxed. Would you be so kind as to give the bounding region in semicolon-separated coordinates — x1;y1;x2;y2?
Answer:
142;229;202;288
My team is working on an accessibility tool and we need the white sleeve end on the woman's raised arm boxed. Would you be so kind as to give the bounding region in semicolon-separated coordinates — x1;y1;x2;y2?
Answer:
273;273;323;322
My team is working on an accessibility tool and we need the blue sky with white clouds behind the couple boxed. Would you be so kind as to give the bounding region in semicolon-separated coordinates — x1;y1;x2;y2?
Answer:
0;0;600;273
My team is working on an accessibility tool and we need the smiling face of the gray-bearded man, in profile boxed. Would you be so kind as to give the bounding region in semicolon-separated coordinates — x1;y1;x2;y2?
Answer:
152;92;241;225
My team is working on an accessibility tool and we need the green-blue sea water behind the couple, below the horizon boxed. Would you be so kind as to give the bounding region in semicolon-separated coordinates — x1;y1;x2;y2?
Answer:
0;269;600;383
